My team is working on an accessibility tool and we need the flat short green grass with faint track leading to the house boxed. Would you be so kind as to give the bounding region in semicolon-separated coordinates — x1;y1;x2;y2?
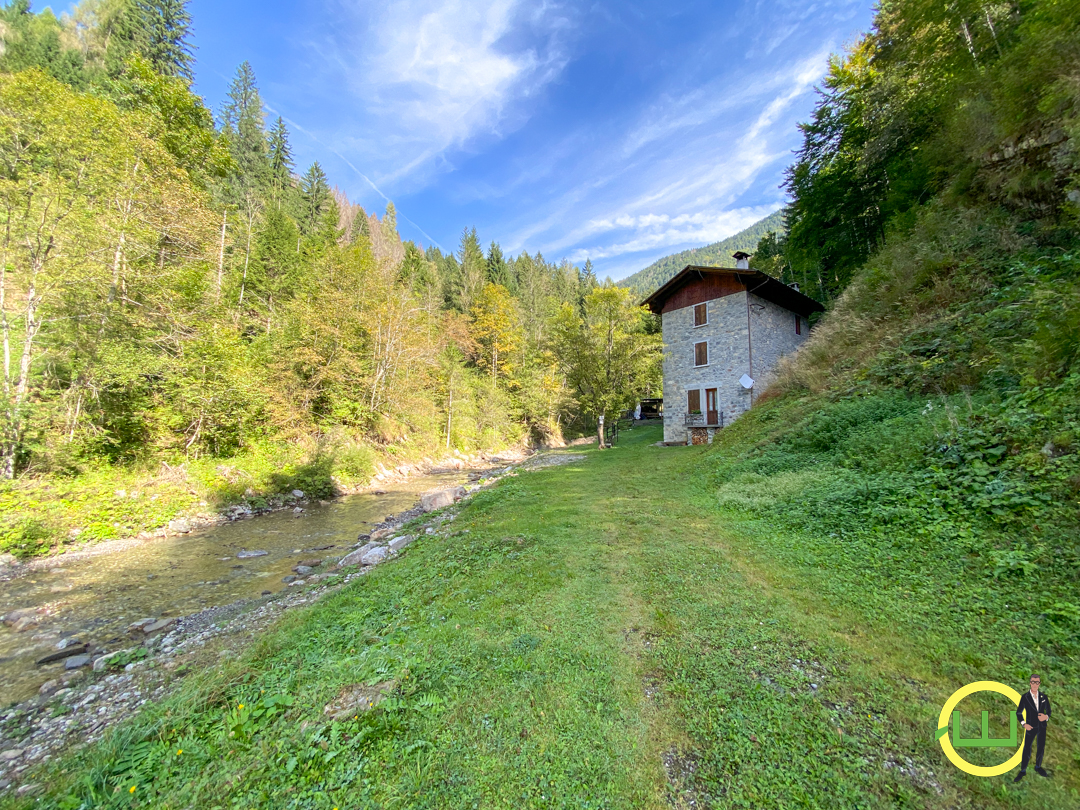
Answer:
8;428;1080;810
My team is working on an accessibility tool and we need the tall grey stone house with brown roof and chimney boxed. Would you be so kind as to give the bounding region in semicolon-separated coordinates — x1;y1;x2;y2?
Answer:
643;252;824;444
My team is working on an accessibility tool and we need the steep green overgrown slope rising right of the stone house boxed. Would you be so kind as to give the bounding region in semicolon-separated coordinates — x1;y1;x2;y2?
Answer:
707;199;1080;751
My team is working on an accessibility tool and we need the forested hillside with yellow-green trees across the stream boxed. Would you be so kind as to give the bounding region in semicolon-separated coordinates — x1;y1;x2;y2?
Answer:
0;0;658;556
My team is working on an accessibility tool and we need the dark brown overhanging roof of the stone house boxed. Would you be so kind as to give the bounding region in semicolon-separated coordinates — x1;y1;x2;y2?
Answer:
642;265;825;318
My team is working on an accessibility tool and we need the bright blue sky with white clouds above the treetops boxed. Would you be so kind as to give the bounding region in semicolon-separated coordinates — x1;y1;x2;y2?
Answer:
78;0;872;279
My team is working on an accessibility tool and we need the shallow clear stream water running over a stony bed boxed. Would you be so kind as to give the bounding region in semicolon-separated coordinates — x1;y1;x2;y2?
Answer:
0;473;464;705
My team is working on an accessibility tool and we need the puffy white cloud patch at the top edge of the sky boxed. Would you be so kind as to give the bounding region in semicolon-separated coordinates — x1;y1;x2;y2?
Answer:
320;0;567;184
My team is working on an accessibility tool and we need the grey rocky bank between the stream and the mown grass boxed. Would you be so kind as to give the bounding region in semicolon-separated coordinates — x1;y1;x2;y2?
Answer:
0;453;583;793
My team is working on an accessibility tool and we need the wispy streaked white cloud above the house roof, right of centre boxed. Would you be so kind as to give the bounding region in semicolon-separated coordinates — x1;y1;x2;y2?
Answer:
527;49;828;261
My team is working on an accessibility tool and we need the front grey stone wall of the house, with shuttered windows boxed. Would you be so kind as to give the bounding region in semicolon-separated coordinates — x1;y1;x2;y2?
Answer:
662;293;750;442
